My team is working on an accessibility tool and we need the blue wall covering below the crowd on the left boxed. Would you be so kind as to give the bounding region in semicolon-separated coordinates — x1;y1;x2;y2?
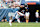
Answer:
0;8;18;21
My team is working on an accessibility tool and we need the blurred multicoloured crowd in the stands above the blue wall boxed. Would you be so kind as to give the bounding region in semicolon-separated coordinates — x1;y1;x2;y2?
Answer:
1;0;24;9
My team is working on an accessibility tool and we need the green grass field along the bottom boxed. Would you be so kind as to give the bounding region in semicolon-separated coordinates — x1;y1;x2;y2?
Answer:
0;22;40;27
